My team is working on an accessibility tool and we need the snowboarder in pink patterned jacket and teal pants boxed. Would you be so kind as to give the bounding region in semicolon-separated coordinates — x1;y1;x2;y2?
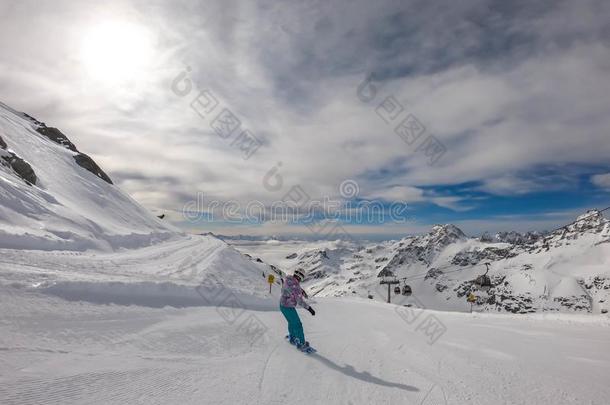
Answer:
280;270;316;352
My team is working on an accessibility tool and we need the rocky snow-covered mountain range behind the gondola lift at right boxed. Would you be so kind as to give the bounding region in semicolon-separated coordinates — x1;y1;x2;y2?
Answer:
246;211;610;313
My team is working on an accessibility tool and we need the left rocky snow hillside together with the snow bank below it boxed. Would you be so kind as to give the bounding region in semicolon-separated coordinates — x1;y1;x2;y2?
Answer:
0;100;281;306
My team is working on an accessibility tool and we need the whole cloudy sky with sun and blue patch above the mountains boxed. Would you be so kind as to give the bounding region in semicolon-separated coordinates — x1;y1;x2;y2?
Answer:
0;0;610;238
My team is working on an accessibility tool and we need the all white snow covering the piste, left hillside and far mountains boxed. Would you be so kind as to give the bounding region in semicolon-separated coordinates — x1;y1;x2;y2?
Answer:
0;99;610;405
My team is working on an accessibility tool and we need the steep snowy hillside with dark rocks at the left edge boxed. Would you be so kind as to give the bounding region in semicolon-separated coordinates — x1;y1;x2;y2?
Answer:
0;103;177;251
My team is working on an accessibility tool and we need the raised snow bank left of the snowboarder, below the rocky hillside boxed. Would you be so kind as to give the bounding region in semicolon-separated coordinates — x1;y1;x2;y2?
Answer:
0;235;269;301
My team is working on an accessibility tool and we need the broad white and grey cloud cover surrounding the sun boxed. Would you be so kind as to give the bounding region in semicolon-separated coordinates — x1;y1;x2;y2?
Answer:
0;0;610;235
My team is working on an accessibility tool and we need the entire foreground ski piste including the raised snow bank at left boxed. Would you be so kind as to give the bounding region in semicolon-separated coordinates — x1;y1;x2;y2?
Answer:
0;236;610;405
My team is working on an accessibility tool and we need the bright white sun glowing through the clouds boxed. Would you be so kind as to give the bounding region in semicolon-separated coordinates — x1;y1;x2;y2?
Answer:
81;21;153;85
